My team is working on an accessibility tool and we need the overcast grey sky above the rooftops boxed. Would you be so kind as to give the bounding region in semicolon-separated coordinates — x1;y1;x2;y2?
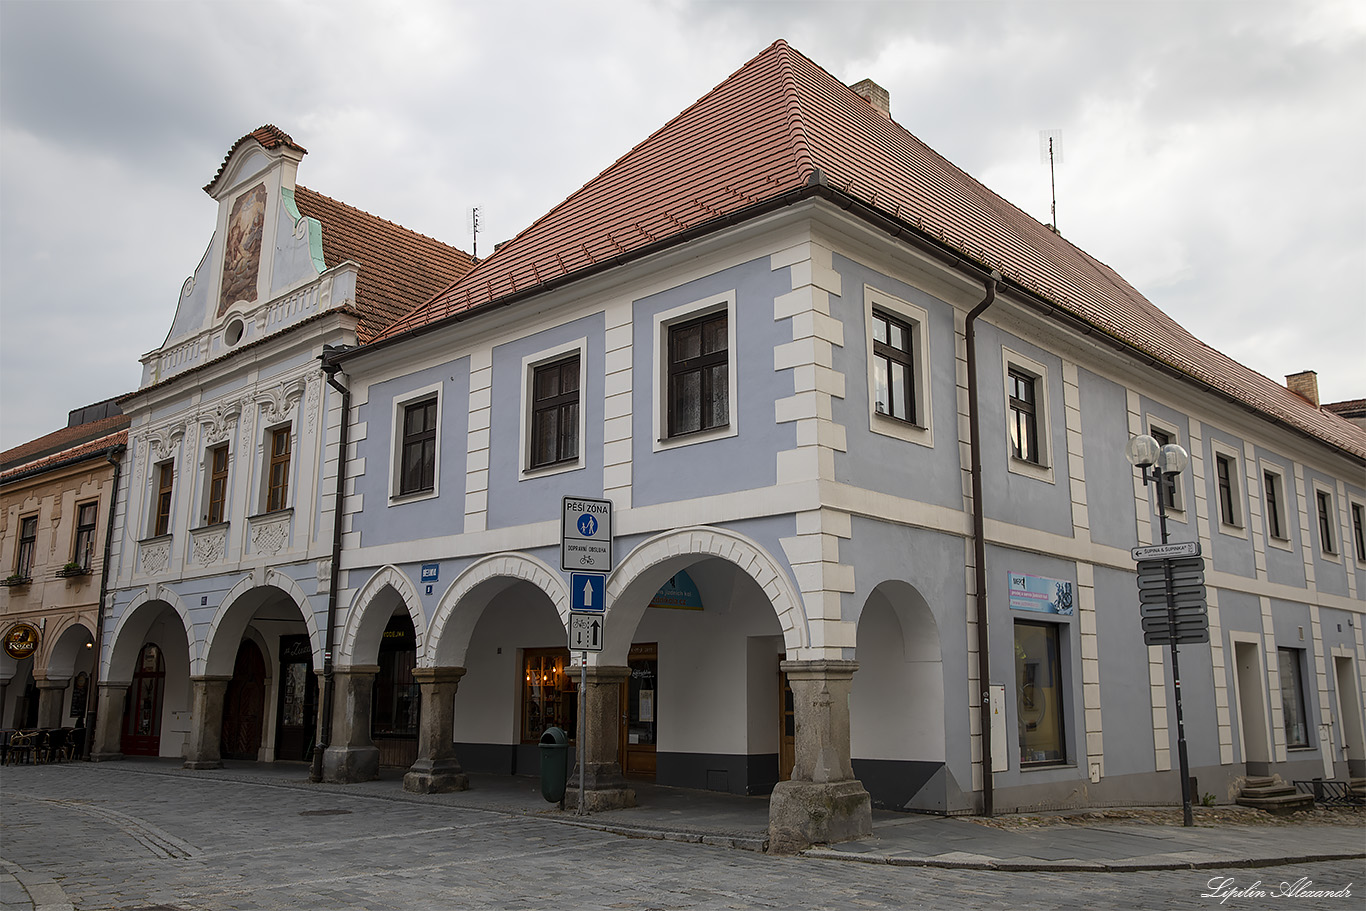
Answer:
0;0;1366;449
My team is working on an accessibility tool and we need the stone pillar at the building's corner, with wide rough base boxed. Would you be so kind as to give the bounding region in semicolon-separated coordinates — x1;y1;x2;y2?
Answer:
769;660;873;854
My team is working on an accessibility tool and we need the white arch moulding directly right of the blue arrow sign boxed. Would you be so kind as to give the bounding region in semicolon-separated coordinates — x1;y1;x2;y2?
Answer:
598;526;810;665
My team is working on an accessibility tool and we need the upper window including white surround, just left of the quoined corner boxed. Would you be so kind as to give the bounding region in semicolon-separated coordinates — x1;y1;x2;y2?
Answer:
654;291;739;451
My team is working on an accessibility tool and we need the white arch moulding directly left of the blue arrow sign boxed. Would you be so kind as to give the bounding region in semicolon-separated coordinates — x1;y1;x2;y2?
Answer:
431;553;570;668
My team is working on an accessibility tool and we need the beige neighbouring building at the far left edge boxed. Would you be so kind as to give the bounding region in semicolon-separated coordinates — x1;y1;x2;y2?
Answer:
0;400;128;743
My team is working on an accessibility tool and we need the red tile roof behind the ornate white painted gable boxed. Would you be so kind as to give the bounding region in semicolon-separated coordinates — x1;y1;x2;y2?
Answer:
294;186;474;344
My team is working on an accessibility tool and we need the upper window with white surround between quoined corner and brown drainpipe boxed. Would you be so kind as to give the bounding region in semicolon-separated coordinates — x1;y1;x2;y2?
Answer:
863;285;934;445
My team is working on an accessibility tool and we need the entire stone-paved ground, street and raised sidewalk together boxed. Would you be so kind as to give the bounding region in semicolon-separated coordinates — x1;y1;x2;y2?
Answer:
0;759;1366;911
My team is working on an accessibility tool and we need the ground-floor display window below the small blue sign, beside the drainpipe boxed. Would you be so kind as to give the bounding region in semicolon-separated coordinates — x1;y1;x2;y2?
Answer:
1015;620;1067;766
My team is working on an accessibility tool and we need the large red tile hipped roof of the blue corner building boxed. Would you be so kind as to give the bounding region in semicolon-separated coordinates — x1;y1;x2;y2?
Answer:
377;41;1366;458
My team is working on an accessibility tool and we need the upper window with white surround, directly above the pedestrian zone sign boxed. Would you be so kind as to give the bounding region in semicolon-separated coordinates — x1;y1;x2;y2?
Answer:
520;339;587;477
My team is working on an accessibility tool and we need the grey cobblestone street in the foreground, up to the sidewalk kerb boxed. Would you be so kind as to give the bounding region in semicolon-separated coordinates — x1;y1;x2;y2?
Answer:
0;763;1366;911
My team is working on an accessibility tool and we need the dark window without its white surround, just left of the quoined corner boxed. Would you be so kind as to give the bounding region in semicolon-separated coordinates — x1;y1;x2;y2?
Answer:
668;311;731;437
